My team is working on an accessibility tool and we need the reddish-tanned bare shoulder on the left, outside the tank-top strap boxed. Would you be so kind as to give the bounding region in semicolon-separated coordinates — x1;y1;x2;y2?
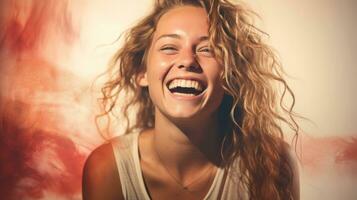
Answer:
82;143;124;200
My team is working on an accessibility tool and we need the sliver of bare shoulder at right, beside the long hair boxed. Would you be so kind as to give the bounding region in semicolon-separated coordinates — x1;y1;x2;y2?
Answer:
282;142;300;200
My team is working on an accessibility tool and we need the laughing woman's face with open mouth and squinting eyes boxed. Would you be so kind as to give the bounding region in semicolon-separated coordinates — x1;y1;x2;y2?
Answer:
139;6;224;122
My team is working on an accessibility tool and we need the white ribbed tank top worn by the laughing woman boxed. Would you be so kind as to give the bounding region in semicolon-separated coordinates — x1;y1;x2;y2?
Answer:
111;132;249;200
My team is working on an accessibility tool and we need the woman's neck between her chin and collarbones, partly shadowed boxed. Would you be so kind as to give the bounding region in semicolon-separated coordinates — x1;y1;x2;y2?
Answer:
153;109;222;177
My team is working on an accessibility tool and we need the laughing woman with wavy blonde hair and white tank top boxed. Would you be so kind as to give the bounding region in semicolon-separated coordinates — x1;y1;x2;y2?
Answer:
83;0;299;200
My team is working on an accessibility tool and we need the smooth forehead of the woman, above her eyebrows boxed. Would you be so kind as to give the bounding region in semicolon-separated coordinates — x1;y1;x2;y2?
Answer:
154;6;208;38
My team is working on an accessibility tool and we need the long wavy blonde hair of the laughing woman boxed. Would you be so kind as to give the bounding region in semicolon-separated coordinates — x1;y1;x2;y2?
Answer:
98;0;299;199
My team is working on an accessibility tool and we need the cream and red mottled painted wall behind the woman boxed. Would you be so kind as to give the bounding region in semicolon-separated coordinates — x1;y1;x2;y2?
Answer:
0;0;357;200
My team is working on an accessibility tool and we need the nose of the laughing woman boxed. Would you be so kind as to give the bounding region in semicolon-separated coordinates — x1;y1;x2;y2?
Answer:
177;50;202;72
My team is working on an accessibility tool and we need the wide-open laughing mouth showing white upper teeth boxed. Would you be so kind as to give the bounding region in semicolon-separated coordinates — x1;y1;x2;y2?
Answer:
167;79;206;96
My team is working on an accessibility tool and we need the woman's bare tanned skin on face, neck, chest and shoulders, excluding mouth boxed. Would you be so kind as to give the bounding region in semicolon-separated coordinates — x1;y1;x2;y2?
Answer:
83;6;299;199
